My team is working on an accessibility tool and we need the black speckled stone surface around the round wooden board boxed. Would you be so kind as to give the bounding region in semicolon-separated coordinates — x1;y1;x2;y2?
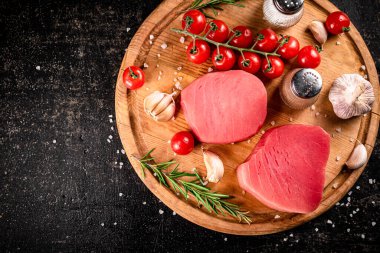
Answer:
0;0;380;252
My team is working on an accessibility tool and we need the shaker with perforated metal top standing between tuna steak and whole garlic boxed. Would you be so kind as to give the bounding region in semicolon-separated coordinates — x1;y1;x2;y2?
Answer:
280;68;322;110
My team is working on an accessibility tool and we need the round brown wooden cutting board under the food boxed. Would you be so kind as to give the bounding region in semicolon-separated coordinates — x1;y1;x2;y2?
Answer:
115;0;380;235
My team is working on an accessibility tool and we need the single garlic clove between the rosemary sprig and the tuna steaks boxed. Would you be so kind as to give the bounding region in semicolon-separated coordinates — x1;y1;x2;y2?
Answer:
203;150;224;183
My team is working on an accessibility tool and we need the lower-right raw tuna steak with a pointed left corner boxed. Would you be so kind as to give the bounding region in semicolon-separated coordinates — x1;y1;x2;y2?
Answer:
237;125;330;213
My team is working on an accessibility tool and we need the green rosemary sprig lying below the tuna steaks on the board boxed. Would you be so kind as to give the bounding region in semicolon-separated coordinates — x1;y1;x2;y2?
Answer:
134;149;252;224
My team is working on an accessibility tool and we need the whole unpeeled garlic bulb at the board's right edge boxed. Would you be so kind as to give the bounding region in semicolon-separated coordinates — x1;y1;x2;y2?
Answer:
329;74;375;119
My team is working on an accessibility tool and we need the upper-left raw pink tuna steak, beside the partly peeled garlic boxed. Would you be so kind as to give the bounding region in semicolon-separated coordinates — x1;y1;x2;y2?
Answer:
181;70;267;144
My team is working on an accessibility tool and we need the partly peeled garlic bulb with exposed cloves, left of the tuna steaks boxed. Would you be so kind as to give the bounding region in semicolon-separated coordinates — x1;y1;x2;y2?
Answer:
144;91;178;121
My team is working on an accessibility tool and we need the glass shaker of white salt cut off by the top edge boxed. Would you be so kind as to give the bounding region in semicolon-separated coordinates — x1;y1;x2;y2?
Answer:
263;0;304;28
